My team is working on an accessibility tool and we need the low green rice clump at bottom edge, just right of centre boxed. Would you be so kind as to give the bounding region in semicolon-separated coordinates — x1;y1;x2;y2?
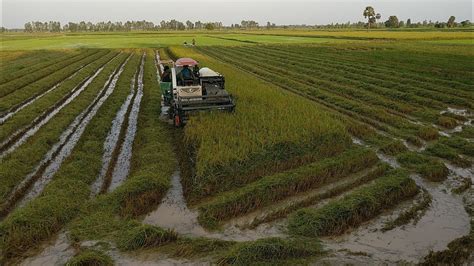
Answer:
217;237;323;265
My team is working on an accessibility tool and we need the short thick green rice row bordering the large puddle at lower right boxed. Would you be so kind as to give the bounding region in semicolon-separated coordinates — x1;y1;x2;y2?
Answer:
288;170;418;237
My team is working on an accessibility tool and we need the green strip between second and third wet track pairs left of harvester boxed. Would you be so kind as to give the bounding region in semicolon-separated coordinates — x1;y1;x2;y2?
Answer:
0;51;124;210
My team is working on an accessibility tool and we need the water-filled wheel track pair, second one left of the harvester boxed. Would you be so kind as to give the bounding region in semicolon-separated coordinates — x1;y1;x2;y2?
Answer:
0;53;130;217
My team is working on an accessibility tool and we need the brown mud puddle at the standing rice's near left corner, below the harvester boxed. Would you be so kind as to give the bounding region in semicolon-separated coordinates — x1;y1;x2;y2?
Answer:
143;171;285;241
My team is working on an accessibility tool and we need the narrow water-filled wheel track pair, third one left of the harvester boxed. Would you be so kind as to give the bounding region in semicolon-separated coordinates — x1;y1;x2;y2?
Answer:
0;54;119;159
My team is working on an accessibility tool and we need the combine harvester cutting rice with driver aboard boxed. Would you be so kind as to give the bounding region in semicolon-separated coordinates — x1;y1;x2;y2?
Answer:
160;58;235;127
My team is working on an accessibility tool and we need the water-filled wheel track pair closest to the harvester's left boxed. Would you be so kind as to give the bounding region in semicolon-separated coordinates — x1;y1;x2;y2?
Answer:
95;53;145;193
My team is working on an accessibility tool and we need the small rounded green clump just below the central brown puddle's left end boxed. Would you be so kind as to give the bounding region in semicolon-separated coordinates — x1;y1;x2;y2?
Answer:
118;225;178;251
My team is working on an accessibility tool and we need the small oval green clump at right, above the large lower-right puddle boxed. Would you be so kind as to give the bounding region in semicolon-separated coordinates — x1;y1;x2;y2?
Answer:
397;152;449;182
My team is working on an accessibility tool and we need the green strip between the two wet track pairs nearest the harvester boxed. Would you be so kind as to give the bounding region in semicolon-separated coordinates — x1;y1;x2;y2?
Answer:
0;51;139;260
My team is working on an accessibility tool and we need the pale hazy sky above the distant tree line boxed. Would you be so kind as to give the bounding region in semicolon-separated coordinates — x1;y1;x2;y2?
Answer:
0;0;473;28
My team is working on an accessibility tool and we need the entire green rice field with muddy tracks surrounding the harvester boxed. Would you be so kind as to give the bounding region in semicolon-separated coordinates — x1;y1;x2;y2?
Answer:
0;31;474;265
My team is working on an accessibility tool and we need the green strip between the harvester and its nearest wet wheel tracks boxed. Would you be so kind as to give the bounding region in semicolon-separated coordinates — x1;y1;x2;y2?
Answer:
69;48;176;244
